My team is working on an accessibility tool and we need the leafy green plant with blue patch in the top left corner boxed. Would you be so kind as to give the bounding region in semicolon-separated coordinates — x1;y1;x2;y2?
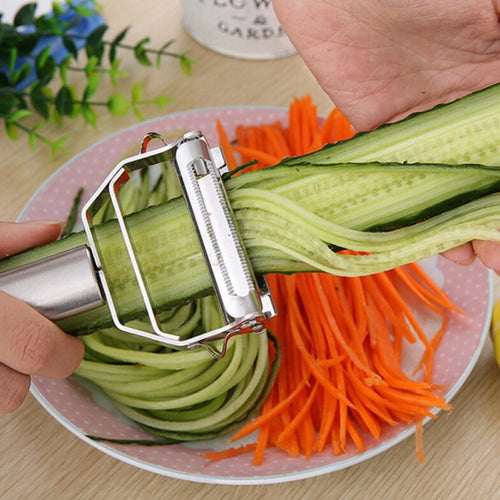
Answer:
0;0;193;154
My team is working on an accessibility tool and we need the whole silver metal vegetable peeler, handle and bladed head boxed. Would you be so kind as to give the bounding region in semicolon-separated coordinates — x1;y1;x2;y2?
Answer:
0;131;276;357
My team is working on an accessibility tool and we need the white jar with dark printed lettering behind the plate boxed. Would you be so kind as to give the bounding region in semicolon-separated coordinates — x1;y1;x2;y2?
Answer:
181;0;295;59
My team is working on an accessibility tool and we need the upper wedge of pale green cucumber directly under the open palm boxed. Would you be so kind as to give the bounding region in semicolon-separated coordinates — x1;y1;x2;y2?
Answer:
284;84;500;165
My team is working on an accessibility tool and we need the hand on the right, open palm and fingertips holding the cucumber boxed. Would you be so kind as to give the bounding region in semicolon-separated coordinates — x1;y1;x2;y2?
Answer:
274;0;500;273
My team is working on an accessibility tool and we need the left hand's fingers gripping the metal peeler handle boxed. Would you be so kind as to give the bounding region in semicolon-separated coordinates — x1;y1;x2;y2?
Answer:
0;222;84;414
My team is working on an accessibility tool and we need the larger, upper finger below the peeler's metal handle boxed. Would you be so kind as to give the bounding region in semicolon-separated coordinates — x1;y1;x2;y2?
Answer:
0;292;84;378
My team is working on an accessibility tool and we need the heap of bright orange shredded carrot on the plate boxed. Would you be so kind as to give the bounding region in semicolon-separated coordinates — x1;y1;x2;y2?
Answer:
207;96;461;465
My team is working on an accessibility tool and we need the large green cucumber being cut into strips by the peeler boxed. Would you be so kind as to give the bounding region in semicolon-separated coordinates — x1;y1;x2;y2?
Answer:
0;85;500;333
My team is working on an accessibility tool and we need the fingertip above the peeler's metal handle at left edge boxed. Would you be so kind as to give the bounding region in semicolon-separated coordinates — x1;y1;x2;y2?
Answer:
0;221;63;258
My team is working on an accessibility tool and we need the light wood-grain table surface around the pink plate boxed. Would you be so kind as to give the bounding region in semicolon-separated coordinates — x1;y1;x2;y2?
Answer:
0;0;500;500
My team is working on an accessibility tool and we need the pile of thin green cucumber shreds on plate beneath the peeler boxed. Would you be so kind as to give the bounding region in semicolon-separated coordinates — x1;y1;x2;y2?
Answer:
76;167;279;444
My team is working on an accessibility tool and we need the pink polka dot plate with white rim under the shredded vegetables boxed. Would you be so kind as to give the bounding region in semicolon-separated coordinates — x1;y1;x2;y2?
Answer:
21;107;493;484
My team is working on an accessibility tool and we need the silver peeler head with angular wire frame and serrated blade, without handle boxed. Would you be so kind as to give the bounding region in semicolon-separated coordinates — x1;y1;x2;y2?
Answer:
82;131;276;358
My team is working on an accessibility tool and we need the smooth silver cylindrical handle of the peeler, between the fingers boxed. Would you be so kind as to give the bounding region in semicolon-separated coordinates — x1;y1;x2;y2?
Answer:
0;245;105;321
